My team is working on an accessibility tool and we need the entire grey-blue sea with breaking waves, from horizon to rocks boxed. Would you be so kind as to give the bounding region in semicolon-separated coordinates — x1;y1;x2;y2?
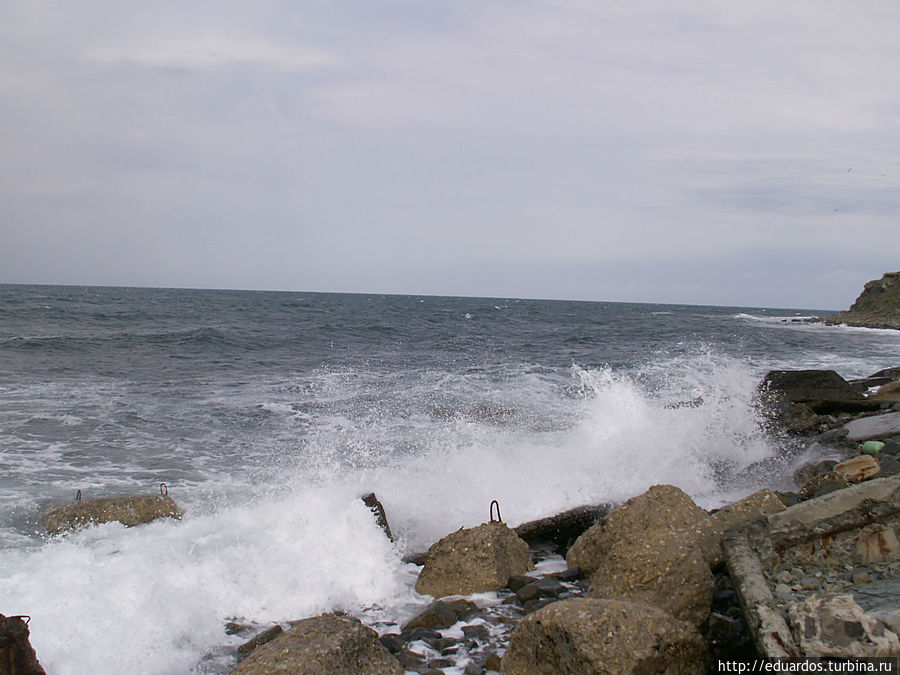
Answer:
0;285;900;675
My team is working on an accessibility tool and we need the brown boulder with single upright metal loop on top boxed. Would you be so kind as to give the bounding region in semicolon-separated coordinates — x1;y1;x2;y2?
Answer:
416;522;534;597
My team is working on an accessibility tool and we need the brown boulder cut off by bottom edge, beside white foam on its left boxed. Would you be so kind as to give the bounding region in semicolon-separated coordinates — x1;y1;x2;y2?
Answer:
232;614;403;675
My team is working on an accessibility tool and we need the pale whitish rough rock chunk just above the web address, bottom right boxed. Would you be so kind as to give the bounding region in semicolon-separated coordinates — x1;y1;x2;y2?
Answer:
789;593;900;658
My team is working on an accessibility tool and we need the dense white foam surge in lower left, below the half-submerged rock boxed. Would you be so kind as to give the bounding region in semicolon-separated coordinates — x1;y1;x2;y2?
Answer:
0;485;413;675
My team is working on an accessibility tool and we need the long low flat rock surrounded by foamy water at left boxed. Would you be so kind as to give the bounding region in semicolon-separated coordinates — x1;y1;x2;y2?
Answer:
44;495;181;534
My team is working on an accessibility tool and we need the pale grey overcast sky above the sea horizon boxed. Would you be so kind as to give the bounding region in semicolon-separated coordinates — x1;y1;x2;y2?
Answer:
0;0;900;309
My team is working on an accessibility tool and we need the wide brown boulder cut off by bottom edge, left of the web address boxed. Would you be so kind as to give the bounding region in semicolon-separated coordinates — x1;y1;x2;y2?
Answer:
500;598;706;675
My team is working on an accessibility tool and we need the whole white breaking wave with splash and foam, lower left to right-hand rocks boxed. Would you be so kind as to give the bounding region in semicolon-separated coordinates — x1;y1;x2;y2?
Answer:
0;349;884;675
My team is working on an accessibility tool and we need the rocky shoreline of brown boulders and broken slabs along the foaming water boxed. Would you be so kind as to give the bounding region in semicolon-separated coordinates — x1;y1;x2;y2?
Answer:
7;367;900;675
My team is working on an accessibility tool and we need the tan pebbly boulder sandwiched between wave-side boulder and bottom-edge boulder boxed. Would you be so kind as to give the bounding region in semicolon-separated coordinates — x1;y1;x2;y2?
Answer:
588;530;715;626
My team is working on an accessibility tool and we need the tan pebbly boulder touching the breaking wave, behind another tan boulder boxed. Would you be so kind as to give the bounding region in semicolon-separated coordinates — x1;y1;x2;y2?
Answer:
566;485;708;575
